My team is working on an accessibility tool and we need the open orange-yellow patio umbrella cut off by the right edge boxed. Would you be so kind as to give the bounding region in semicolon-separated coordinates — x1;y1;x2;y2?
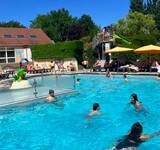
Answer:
134;45;160;54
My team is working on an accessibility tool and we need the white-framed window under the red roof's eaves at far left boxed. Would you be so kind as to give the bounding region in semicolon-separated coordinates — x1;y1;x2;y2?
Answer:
0;48;15;63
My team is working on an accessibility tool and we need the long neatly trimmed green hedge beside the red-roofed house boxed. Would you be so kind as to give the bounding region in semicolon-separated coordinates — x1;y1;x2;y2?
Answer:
31;41;83;62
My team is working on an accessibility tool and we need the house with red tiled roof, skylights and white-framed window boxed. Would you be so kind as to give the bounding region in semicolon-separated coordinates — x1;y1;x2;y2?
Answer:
0;27;52;64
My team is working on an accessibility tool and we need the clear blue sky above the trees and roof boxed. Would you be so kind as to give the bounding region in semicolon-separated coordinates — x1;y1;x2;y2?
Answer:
0;0;130;27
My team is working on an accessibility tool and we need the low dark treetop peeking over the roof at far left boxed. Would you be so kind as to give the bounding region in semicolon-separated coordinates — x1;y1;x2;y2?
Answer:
0;21;25;28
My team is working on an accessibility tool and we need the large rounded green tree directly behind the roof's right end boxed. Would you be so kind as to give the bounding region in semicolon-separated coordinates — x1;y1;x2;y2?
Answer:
31;8;77;41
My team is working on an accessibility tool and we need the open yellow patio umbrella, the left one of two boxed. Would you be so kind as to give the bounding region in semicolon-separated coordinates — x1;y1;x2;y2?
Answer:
105;47;133;53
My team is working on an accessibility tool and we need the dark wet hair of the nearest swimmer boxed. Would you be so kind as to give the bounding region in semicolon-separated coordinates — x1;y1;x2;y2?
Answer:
129;122;143;140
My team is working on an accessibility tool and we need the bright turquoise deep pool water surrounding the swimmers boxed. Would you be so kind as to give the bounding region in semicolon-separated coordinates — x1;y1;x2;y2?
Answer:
0;75;160;150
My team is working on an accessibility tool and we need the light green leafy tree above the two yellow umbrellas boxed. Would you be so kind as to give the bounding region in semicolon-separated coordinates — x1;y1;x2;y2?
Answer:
114;12;158;46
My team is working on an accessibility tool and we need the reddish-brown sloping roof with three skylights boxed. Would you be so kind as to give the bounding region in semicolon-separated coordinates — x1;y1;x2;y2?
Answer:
0;27;52;47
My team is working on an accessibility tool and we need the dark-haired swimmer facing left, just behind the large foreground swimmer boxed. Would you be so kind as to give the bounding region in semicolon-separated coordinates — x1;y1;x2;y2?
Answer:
130;94;142;111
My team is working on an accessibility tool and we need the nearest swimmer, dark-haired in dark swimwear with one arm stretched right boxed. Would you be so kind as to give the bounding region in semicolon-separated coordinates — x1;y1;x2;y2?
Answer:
111;122;160;150
